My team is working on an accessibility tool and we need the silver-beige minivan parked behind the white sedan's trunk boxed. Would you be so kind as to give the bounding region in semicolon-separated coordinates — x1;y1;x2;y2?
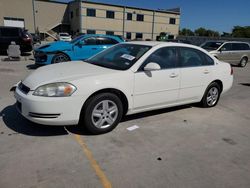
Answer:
201;41;250;67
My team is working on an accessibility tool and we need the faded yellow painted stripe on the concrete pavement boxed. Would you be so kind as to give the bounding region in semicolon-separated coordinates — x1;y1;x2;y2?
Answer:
74;134;112;188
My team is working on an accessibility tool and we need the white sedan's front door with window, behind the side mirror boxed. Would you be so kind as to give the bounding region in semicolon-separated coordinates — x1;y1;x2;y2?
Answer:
133;47;180;110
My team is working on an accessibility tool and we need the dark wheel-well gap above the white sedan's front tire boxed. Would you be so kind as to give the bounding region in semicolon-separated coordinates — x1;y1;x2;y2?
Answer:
83;88;128;115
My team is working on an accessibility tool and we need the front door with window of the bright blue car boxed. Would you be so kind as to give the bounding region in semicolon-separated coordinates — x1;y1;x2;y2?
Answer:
74;37;98;60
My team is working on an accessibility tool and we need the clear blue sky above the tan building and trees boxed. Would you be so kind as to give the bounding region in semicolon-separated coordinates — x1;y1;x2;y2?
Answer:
61;0;250;33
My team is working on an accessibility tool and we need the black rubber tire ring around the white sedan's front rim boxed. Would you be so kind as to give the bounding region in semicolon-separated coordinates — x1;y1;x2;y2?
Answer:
81;93;123;134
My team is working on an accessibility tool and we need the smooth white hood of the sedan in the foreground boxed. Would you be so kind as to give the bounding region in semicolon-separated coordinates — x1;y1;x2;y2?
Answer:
23;61;117;90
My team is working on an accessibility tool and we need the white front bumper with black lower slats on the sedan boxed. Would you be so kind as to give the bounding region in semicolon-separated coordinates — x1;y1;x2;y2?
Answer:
14;87;86;126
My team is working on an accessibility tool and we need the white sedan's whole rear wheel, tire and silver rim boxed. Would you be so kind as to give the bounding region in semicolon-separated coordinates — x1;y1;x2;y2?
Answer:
201;82;221;108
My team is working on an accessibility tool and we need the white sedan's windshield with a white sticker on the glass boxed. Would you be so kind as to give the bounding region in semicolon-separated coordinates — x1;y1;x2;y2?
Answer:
85;44;151;70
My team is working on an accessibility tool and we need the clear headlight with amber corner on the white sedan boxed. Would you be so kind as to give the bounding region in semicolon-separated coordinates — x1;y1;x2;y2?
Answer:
33;82;76;97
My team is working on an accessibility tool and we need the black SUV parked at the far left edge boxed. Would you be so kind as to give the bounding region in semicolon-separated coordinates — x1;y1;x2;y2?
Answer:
0;26;33;52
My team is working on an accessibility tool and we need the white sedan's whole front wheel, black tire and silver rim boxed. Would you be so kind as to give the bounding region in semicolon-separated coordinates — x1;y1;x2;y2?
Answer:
80;93;123;134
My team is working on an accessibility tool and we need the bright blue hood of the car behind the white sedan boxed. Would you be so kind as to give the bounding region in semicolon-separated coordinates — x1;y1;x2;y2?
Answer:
35;41;72;52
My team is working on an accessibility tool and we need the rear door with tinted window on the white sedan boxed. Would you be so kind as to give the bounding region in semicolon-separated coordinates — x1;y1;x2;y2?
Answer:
179;47;214;103
